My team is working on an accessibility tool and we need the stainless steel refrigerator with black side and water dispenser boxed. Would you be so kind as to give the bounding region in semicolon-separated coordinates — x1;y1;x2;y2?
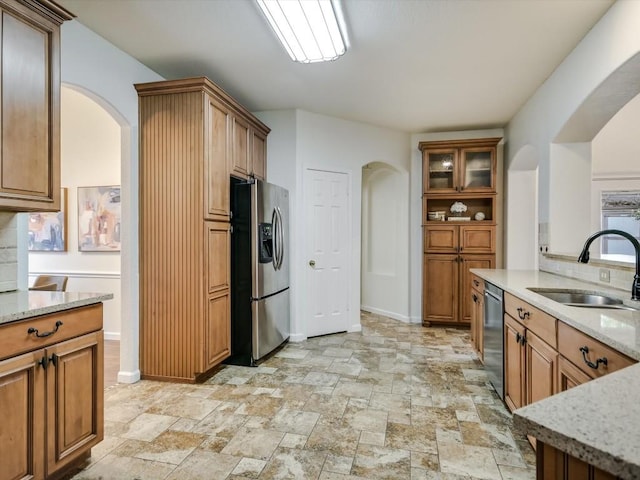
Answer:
227;178;290;365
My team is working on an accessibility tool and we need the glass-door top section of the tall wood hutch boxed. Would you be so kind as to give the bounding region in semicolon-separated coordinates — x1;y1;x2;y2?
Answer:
418;138;500;194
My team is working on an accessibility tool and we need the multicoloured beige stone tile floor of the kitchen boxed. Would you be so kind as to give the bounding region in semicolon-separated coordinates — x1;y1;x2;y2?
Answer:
73;313;535;480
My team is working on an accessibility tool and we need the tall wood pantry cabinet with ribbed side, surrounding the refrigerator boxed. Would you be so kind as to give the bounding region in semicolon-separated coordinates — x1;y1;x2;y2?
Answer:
135;77;269;382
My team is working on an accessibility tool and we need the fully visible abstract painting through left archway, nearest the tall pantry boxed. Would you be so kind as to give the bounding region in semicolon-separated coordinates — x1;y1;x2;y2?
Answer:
78;185;122;252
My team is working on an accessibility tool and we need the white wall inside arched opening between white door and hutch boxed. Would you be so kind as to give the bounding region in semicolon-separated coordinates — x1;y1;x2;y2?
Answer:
361;162;410;322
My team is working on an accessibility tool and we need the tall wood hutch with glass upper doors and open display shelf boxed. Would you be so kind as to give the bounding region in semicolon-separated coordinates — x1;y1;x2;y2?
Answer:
418;138;500;326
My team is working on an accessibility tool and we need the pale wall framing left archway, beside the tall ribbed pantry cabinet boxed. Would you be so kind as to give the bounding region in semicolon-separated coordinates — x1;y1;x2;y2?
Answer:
59;20;162;382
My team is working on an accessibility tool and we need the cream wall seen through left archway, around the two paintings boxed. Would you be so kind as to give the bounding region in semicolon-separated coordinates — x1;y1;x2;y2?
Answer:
29;87;121;339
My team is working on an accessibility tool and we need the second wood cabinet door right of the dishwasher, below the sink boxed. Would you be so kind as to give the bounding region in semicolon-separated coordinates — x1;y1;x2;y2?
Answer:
525;331;558;405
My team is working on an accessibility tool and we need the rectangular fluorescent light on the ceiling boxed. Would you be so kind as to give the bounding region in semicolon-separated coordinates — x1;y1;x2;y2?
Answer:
256;0;347;63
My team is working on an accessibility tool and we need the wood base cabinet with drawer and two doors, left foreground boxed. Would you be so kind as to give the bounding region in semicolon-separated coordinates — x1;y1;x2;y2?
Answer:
0;304;104;480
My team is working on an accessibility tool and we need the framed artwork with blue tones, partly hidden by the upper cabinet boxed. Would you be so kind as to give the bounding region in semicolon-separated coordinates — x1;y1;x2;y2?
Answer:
28;188;67;252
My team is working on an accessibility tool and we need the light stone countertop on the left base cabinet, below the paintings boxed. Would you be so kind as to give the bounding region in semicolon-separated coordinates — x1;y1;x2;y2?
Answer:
0;290;113;325
